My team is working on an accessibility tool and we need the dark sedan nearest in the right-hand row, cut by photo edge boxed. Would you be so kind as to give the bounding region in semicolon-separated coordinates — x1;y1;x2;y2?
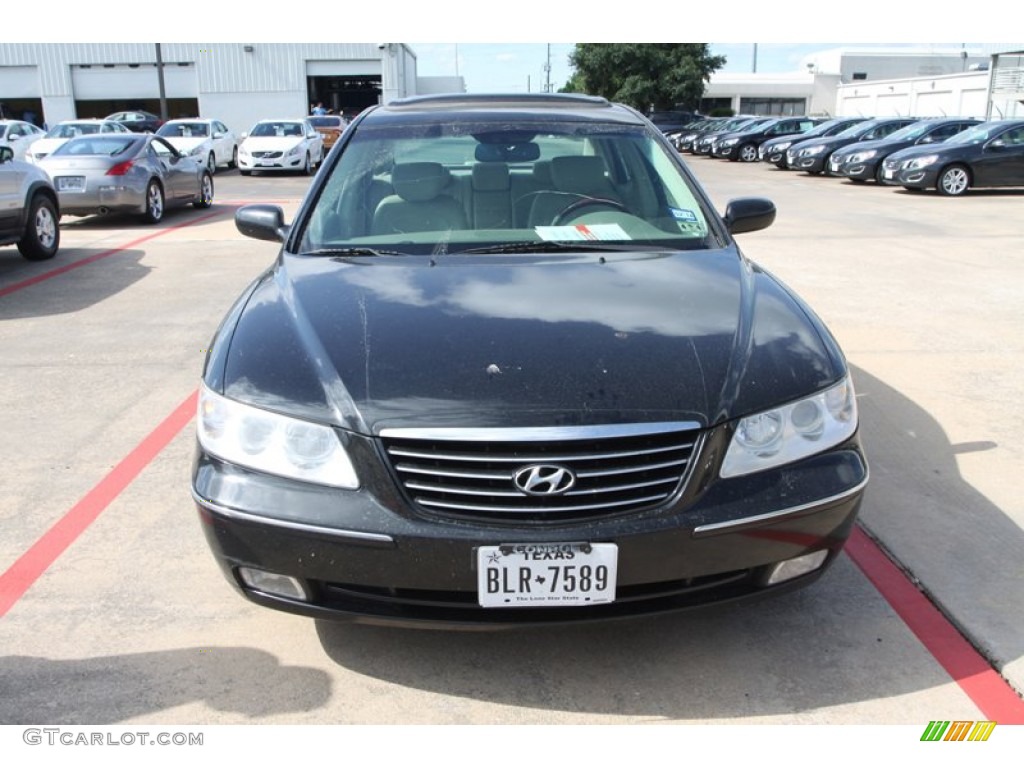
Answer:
883;120;1024;197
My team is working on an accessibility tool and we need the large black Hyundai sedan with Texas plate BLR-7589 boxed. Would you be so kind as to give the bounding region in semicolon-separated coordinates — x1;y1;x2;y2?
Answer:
191;94;867;627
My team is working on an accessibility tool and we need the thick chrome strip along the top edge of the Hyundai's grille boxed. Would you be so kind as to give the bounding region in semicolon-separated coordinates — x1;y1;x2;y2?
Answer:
379;421;702;442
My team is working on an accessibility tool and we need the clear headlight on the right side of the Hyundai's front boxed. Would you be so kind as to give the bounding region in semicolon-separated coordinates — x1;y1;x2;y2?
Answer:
721;376;857;477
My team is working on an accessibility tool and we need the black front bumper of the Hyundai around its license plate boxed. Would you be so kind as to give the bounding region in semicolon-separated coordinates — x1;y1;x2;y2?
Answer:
193;439;867;627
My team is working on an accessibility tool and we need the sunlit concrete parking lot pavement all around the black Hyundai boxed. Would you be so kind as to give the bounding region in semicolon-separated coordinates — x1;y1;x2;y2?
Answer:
0;167;1024;728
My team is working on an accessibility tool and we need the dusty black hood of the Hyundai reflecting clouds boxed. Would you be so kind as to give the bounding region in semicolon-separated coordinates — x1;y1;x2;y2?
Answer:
204;249;845;434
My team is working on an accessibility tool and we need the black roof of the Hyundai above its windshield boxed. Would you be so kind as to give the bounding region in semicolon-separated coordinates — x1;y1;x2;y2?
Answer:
362;93;647;125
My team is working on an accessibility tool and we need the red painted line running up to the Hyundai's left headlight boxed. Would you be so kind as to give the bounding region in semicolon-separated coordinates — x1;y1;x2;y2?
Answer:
0;391;199;617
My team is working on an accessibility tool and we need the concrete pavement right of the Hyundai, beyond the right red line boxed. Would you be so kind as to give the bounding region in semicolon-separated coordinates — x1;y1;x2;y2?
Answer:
690;159;1024;691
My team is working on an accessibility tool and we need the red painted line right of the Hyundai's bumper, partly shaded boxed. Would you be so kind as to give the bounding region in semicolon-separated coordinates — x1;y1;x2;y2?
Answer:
846;527;1024;725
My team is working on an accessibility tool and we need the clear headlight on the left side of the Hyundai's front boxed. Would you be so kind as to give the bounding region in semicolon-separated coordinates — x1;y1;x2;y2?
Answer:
197;385;359;488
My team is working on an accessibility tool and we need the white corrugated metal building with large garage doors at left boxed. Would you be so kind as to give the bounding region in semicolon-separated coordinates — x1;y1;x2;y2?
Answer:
0;43;465;132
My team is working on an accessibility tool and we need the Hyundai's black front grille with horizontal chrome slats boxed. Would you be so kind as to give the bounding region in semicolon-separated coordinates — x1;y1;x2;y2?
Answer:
382;423;699;522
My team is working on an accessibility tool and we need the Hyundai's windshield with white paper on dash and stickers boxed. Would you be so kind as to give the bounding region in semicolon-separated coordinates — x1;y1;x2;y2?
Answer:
300;122;709;253
